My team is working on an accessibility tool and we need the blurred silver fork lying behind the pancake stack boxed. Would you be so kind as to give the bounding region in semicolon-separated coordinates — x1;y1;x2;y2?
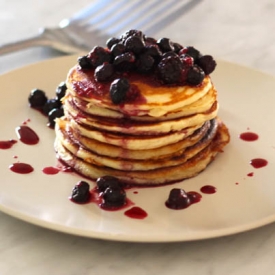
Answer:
0;0;202;55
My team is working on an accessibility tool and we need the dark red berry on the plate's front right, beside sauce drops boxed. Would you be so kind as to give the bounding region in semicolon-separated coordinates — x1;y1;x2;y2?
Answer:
165;188;191;209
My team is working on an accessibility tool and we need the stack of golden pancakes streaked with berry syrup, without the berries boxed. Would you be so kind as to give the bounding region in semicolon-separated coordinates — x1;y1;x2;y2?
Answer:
55;65;229;185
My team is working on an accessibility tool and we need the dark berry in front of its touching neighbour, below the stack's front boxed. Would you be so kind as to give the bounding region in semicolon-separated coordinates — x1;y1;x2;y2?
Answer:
102;187;126;207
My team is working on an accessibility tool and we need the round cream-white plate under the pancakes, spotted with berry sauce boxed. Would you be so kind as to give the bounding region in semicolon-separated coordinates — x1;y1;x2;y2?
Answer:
0;57;275;242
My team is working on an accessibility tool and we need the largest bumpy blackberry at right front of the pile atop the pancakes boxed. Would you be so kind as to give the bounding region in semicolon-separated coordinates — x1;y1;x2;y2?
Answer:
158;56;182;84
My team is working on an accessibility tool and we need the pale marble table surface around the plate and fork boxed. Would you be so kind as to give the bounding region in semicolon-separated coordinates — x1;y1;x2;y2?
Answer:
0;0;275;275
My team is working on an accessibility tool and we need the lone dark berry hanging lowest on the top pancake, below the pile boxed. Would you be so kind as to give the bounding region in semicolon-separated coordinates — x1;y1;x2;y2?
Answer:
110;78;130;104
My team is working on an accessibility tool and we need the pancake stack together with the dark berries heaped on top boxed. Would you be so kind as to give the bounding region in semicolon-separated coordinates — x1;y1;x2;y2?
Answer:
54;30;230;186
